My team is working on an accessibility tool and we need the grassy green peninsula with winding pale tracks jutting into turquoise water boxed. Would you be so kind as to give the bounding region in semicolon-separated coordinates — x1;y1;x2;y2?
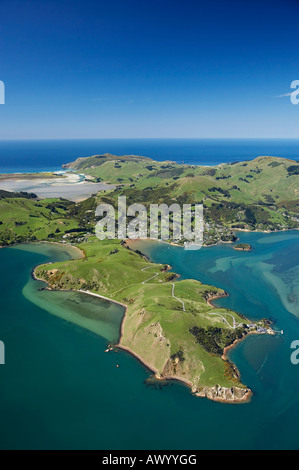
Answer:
35;239;260;401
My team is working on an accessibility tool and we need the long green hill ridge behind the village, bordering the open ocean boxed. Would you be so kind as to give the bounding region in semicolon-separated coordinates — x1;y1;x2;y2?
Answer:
65;154;299;214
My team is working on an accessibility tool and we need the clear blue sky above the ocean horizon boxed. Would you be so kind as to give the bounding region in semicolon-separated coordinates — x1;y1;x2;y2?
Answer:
0;0;299;139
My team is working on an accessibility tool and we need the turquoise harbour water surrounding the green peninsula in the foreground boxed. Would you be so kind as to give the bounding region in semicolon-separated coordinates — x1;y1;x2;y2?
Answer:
0;231;299;450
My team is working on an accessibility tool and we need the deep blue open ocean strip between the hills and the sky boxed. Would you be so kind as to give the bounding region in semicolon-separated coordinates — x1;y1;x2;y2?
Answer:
0;139;299;173
